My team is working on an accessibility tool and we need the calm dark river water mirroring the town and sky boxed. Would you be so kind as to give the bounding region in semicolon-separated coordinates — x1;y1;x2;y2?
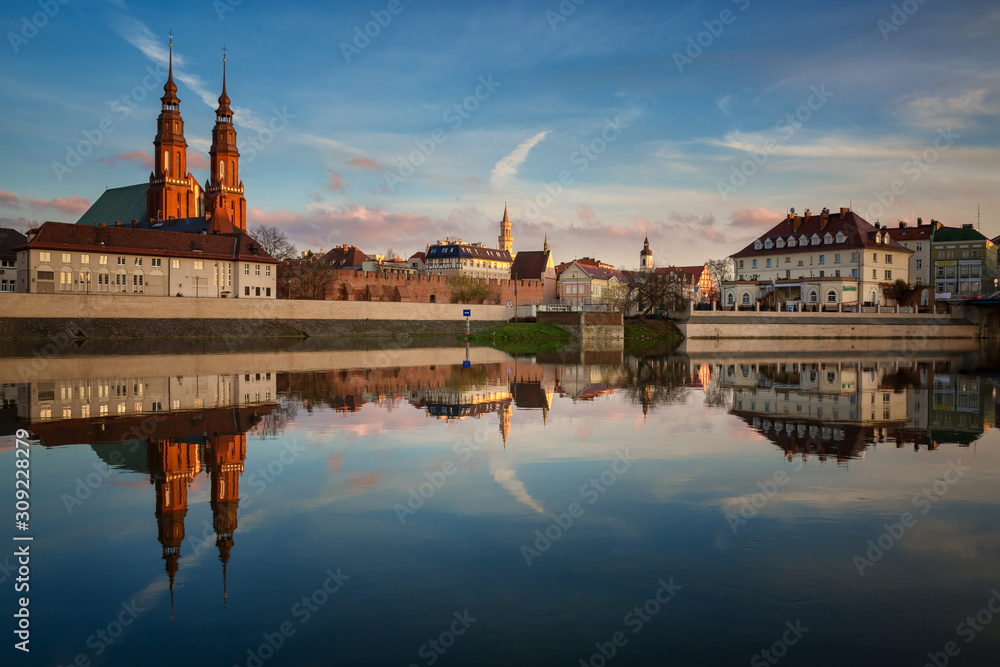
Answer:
0;349;1000;667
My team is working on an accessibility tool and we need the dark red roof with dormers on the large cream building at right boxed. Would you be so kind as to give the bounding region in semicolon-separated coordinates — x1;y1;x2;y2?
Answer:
732;211;913;257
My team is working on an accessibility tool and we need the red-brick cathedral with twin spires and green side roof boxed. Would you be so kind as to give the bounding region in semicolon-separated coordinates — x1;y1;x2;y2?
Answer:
77;36;247;234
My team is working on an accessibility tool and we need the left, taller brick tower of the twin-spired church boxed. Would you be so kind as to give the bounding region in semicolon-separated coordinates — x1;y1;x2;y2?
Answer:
146;35;204;220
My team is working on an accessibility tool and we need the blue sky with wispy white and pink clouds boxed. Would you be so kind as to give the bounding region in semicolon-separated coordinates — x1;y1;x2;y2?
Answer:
0;0;1000;268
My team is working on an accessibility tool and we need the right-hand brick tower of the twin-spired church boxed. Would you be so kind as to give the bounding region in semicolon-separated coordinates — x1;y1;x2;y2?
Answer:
205;49;247;230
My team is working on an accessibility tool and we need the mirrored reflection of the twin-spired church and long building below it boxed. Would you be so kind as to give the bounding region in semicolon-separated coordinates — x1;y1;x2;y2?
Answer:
9;372;279;617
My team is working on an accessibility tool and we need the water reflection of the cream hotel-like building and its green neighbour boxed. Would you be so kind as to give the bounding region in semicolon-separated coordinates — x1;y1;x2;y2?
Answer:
716;359;996;463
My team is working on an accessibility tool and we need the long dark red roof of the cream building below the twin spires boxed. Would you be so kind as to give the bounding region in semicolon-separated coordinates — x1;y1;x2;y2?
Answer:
15;222;278;264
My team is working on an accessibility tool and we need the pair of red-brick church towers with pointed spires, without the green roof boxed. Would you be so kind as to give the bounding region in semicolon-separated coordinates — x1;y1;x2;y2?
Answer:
146;34;246;233
